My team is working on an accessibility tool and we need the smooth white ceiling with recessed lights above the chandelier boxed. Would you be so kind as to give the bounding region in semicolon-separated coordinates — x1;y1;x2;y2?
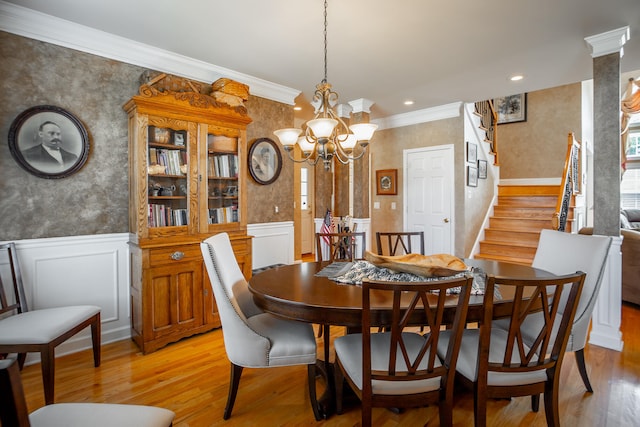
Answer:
1;0;640;119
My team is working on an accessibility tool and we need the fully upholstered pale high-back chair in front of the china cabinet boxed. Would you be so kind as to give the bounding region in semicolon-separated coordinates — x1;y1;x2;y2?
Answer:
200;233;324;420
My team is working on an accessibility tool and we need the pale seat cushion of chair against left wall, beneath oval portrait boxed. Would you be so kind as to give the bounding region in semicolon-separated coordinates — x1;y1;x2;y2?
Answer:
0;305;100;344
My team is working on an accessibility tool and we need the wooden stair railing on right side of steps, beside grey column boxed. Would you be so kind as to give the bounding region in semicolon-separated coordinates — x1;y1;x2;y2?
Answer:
551;132;582;231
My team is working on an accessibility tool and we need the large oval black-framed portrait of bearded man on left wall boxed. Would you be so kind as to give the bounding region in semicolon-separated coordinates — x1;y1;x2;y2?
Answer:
9;105;89;179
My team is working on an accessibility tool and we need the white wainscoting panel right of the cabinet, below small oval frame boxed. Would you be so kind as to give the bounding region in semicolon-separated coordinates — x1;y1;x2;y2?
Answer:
247;221;295;270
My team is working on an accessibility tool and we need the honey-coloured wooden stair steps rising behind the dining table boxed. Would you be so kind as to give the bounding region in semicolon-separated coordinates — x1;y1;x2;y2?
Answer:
474;185;572;265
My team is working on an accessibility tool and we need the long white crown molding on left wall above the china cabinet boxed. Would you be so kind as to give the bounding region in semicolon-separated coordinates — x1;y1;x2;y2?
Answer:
0;0;300;105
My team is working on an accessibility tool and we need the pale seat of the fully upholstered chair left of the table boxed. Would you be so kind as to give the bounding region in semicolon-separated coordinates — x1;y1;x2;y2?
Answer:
247;313;317;366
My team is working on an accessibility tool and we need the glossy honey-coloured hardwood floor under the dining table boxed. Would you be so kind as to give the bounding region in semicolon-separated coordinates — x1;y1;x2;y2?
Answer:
22;305;640;427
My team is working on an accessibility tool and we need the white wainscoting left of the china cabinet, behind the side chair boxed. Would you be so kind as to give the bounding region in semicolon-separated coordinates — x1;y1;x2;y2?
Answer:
0;233;131;363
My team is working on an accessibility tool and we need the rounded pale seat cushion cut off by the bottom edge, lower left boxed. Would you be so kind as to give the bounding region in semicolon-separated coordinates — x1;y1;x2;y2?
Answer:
29;403;175;427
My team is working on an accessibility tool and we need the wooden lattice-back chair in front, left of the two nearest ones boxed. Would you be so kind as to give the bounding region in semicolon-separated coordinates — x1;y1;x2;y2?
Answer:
334;275;473;427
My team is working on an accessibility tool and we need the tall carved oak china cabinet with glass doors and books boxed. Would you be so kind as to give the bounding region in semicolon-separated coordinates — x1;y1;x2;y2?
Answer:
124;74;251;353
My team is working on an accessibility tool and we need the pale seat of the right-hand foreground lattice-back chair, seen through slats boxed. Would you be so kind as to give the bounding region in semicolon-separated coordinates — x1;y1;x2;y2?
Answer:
438;328;547;386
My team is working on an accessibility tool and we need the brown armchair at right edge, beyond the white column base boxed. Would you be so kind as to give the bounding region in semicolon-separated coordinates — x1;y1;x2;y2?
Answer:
579;227;640;305
